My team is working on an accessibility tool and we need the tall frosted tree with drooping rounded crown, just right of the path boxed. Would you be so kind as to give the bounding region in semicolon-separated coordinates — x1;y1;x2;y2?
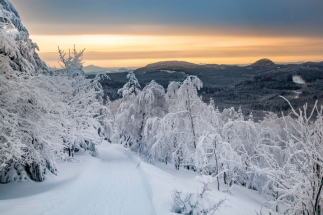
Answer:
145;76;211;169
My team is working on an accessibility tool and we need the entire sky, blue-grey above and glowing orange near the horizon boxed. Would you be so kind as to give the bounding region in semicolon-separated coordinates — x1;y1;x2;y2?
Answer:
11;0;323;67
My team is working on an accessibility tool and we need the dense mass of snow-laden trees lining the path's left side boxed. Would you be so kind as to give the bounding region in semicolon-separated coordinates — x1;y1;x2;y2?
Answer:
0;0;109;183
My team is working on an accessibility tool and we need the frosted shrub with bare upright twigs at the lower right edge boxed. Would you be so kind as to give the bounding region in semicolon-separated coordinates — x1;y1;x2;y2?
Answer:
266;100;323;215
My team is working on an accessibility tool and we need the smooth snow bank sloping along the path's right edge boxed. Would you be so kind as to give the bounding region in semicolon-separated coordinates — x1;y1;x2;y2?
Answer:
140;155;275;215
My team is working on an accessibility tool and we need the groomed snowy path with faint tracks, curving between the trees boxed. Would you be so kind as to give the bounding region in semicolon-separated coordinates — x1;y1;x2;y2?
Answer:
0;145;155;215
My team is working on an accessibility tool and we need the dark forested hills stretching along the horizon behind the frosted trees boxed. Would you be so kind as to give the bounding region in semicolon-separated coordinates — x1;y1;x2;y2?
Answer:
96;58;323;119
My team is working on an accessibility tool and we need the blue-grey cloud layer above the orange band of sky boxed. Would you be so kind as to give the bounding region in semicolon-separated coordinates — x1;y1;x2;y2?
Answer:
12;0;323;37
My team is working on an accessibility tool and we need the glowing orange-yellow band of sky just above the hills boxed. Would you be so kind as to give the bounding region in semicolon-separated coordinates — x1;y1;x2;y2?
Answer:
30;35;323;67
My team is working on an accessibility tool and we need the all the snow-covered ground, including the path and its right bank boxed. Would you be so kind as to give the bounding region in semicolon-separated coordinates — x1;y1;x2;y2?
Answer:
0;144;274;215
